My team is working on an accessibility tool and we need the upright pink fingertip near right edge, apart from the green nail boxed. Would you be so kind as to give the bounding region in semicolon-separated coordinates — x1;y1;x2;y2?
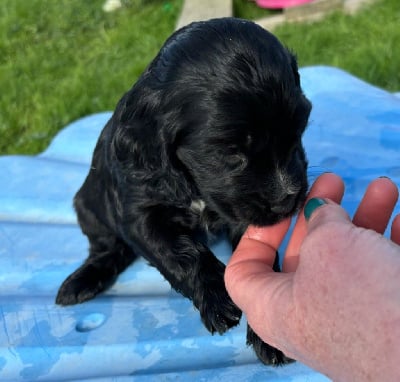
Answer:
353;178;399;234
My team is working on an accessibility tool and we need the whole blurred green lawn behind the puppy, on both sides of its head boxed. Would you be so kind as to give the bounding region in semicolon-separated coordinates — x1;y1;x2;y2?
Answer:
0;0;400;155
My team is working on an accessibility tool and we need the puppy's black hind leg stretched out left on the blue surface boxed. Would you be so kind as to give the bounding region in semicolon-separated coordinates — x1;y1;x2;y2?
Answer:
56;235;136;305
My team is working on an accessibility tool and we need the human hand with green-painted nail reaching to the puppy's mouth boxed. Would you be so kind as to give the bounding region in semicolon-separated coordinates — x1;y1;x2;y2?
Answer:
225;174;400;381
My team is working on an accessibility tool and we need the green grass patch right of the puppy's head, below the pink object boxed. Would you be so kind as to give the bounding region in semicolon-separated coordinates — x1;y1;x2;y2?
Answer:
274;0;400;91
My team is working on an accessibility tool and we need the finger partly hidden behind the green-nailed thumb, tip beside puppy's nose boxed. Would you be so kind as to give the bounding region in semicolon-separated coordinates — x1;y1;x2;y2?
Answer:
282;173;344;272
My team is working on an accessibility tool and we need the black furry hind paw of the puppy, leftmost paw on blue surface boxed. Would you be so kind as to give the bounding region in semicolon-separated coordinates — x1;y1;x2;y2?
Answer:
56;265;111;305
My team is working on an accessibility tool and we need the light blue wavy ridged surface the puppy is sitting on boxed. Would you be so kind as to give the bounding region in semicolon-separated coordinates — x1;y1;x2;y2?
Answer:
0;67;400;382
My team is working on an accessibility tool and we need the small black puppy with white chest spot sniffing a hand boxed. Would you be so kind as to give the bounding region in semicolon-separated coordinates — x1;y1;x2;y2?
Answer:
56;18;311;364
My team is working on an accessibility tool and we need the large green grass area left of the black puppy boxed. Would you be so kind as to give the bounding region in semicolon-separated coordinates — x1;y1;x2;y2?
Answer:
0;0;182;154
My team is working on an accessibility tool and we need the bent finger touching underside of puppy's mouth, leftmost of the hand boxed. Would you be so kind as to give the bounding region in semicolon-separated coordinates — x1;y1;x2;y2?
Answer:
225;219;290;311
